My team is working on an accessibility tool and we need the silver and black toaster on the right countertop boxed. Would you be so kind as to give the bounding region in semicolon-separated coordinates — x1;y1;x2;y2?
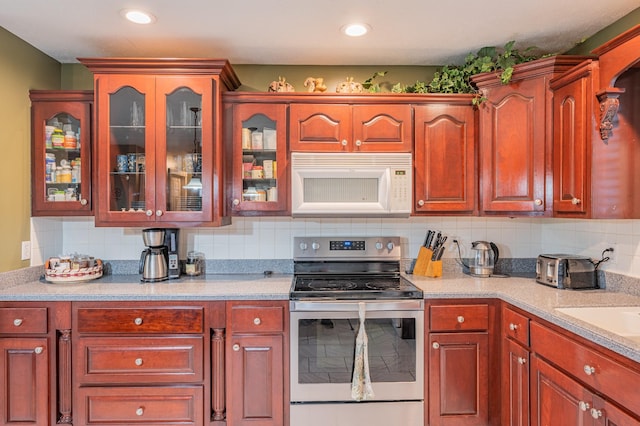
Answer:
536;254;598;289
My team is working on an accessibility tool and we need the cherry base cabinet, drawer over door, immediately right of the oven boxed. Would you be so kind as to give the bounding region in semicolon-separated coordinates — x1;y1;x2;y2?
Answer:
425;303;498;426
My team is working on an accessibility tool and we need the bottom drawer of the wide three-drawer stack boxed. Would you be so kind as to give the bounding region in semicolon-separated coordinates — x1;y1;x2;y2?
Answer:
74;386;204;426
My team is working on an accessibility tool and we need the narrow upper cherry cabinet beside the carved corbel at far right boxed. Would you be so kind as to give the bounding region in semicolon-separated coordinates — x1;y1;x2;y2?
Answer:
550;59;598;218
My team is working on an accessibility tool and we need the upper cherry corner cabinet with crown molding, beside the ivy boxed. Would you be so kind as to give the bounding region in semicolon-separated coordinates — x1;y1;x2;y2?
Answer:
472;56;586;216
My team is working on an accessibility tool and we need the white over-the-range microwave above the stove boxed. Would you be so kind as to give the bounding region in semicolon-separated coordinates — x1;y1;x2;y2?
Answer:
291;152;413;217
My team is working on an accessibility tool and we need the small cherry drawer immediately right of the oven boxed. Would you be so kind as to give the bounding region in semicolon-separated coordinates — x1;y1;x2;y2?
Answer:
430;304;489;331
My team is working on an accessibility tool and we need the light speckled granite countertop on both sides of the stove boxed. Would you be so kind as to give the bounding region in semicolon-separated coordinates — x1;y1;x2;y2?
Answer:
0;272;640;362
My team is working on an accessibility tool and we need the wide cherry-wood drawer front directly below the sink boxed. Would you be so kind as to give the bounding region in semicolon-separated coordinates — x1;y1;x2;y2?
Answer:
531;323;640;413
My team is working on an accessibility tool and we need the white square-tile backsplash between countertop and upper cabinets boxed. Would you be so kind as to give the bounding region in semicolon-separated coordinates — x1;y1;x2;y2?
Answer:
31;217;640;277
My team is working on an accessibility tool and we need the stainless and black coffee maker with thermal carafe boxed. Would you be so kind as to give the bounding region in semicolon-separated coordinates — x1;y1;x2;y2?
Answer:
140;228;180;283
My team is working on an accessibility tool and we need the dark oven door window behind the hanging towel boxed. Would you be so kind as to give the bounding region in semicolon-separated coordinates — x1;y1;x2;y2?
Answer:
298;318;416;384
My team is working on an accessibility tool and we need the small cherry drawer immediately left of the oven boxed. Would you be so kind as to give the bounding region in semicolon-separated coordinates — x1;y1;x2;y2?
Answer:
230;305;285;333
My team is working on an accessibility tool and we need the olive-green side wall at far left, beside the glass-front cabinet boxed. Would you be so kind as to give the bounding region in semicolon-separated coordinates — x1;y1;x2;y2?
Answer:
0;27;61;272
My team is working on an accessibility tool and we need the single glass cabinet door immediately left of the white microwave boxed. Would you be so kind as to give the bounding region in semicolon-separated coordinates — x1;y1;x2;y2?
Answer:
232;104;287;212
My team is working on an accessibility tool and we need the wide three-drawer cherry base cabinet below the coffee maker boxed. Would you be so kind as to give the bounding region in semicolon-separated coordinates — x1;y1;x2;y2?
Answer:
72;302;210;426
